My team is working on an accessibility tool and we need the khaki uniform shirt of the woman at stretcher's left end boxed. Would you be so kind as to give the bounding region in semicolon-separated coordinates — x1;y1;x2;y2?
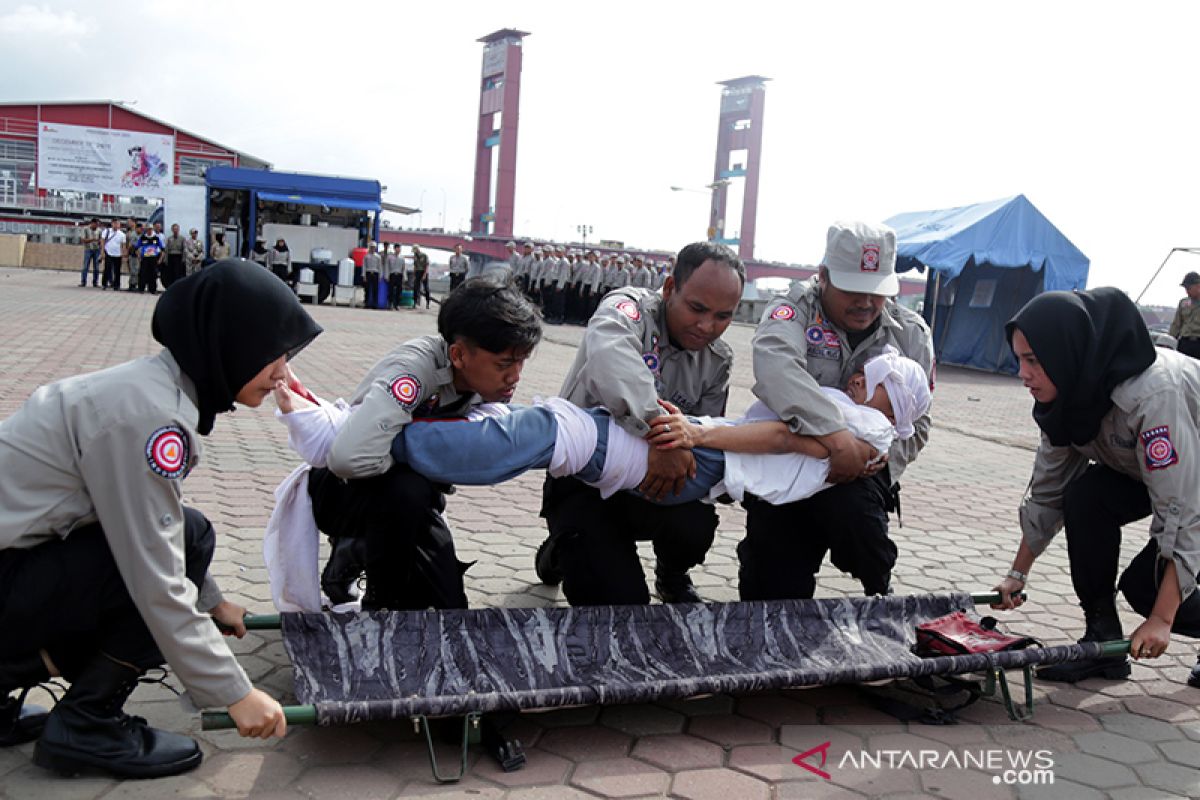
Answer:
0;350;251;706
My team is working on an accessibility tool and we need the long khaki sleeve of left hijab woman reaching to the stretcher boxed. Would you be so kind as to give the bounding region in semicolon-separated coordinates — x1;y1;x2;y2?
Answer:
79;421;252;708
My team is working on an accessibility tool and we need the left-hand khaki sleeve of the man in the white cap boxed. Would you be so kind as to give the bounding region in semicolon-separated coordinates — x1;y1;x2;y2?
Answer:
751;302;846;437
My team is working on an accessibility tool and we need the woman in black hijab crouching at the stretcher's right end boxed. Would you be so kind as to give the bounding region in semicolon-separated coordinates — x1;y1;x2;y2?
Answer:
996;288;1200;686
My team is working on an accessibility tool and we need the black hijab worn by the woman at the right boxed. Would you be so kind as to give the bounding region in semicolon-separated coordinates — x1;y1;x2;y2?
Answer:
1004;287;1157;447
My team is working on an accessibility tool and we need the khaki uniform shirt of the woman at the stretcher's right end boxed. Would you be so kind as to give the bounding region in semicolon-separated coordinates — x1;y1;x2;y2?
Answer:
1019;348;1200;600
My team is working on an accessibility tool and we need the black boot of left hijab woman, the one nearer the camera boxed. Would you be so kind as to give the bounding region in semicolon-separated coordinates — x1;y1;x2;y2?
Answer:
34;654;203;777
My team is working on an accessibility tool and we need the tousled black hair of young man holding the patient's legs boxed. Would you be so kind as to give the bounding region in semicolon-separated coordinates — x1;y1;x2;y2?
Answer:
438;276;541;354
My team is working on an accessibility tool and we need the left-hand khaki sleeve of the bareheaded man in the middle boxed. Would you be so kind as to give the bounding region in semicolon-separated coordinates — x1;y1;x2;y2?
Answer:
578;296;666;438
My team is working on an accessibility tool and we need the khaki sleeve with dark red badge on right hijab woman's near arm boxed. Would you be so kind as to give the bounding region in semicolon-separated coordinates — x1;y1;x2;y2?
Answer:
1138;391;1200;600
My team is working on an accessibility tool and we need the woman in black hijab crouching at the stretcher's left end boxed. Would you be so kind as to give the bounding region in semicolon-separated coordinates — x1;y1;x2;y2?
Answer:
0;259;320;777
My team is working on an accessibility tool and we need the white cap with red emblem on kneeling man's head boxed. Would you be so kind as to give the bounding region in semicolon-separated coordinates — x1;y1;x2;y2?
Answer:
821;222;900;297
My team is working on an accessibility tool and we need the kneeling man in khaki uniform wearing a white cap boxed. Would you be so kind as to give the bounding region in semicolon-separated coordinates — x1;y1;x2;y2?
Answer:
738;222;934;600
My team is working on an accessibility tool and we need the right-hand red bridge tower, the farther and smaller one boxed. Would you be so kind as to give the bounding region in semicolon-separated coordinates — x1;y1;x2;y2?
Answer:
708;76;770;259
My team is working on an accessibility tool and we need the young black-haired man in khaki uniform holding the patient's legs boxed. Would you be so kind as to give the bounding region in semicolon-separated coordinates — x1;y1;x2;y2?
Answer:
308;277;541;609
